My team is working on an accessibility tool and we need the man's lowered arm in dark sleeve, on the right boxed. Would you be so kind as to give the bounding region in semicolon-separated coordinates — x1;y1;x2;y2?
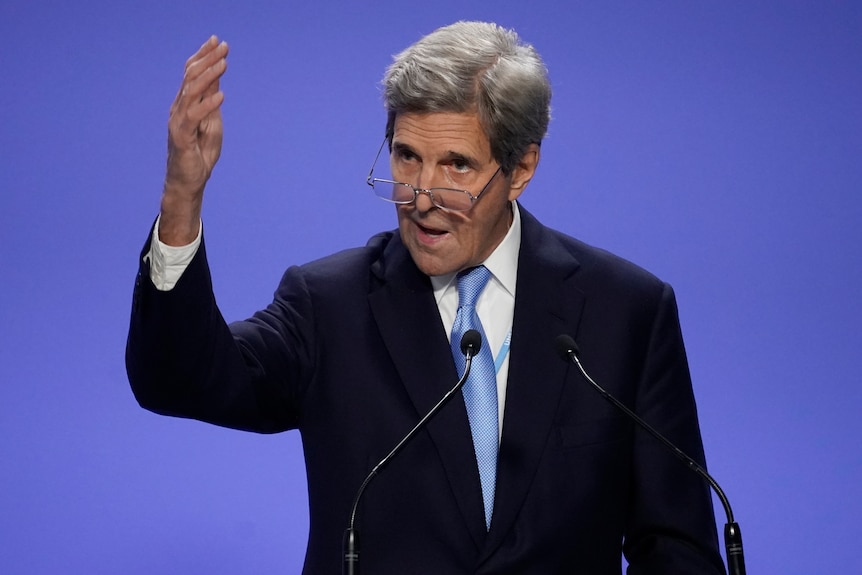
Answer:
624;284;724;575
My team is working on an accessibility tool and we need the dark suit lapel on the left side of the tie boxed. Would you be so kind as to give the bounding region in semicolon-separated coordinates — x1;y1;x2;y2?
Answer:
369;234;487;548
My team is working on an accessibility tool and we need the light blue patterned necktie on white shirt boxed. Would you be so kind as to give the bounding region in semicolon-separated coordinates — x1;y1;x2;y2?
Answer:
451;266;498;529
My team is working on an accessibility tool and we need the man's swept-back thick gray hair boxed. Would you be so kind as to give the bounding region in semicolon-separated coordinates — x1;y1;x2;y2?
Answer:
383;22;551;174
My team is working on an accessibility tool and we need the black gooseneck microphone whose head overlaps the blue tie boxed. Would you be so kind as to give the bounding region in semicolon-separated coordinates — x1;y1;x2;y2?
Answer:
342;329;482;575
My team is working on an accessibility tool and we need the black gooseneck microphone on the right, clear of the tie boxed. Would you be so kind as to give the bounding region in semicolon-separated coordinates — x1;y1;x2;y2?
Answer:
556;334;745;575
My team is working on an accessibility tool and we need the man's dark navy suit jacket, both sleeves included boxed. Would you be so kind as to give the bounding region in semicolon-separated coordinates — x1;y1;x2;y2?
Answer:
126;208;723;575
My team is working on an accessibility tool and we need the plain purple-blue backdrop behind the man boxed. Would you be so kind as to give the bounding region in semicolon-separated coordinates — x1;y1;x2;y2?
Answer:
0;0;862;575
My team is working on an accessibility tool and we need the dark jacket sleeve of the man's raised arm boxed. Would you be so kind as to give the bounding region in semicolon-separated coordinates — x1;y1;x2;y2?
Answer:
126;227;313;433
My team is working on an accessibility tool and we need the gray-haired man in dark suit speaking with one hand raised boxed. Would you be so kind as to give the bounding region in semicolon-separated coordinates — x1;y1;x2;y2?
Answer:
127;22;723;575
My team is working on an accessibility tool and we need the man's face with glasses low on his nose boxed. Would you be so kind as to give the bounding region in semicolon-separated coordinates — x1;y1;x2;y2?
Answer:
391;112;538;275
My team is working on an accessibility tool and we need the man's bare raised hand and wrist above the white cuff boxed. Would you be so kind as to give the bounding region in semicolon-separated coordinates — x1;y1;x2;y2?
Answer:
159;36;228;245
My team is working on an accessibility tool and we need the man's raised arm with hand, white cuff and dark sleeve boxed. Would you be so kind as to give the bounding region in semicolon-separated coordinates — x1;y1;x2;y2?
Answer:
126;36;306;432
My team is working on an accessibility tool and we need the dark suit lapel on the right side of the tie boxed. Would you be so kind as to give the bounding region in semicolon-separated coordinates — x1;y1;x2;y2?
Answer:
482;208;583;559
